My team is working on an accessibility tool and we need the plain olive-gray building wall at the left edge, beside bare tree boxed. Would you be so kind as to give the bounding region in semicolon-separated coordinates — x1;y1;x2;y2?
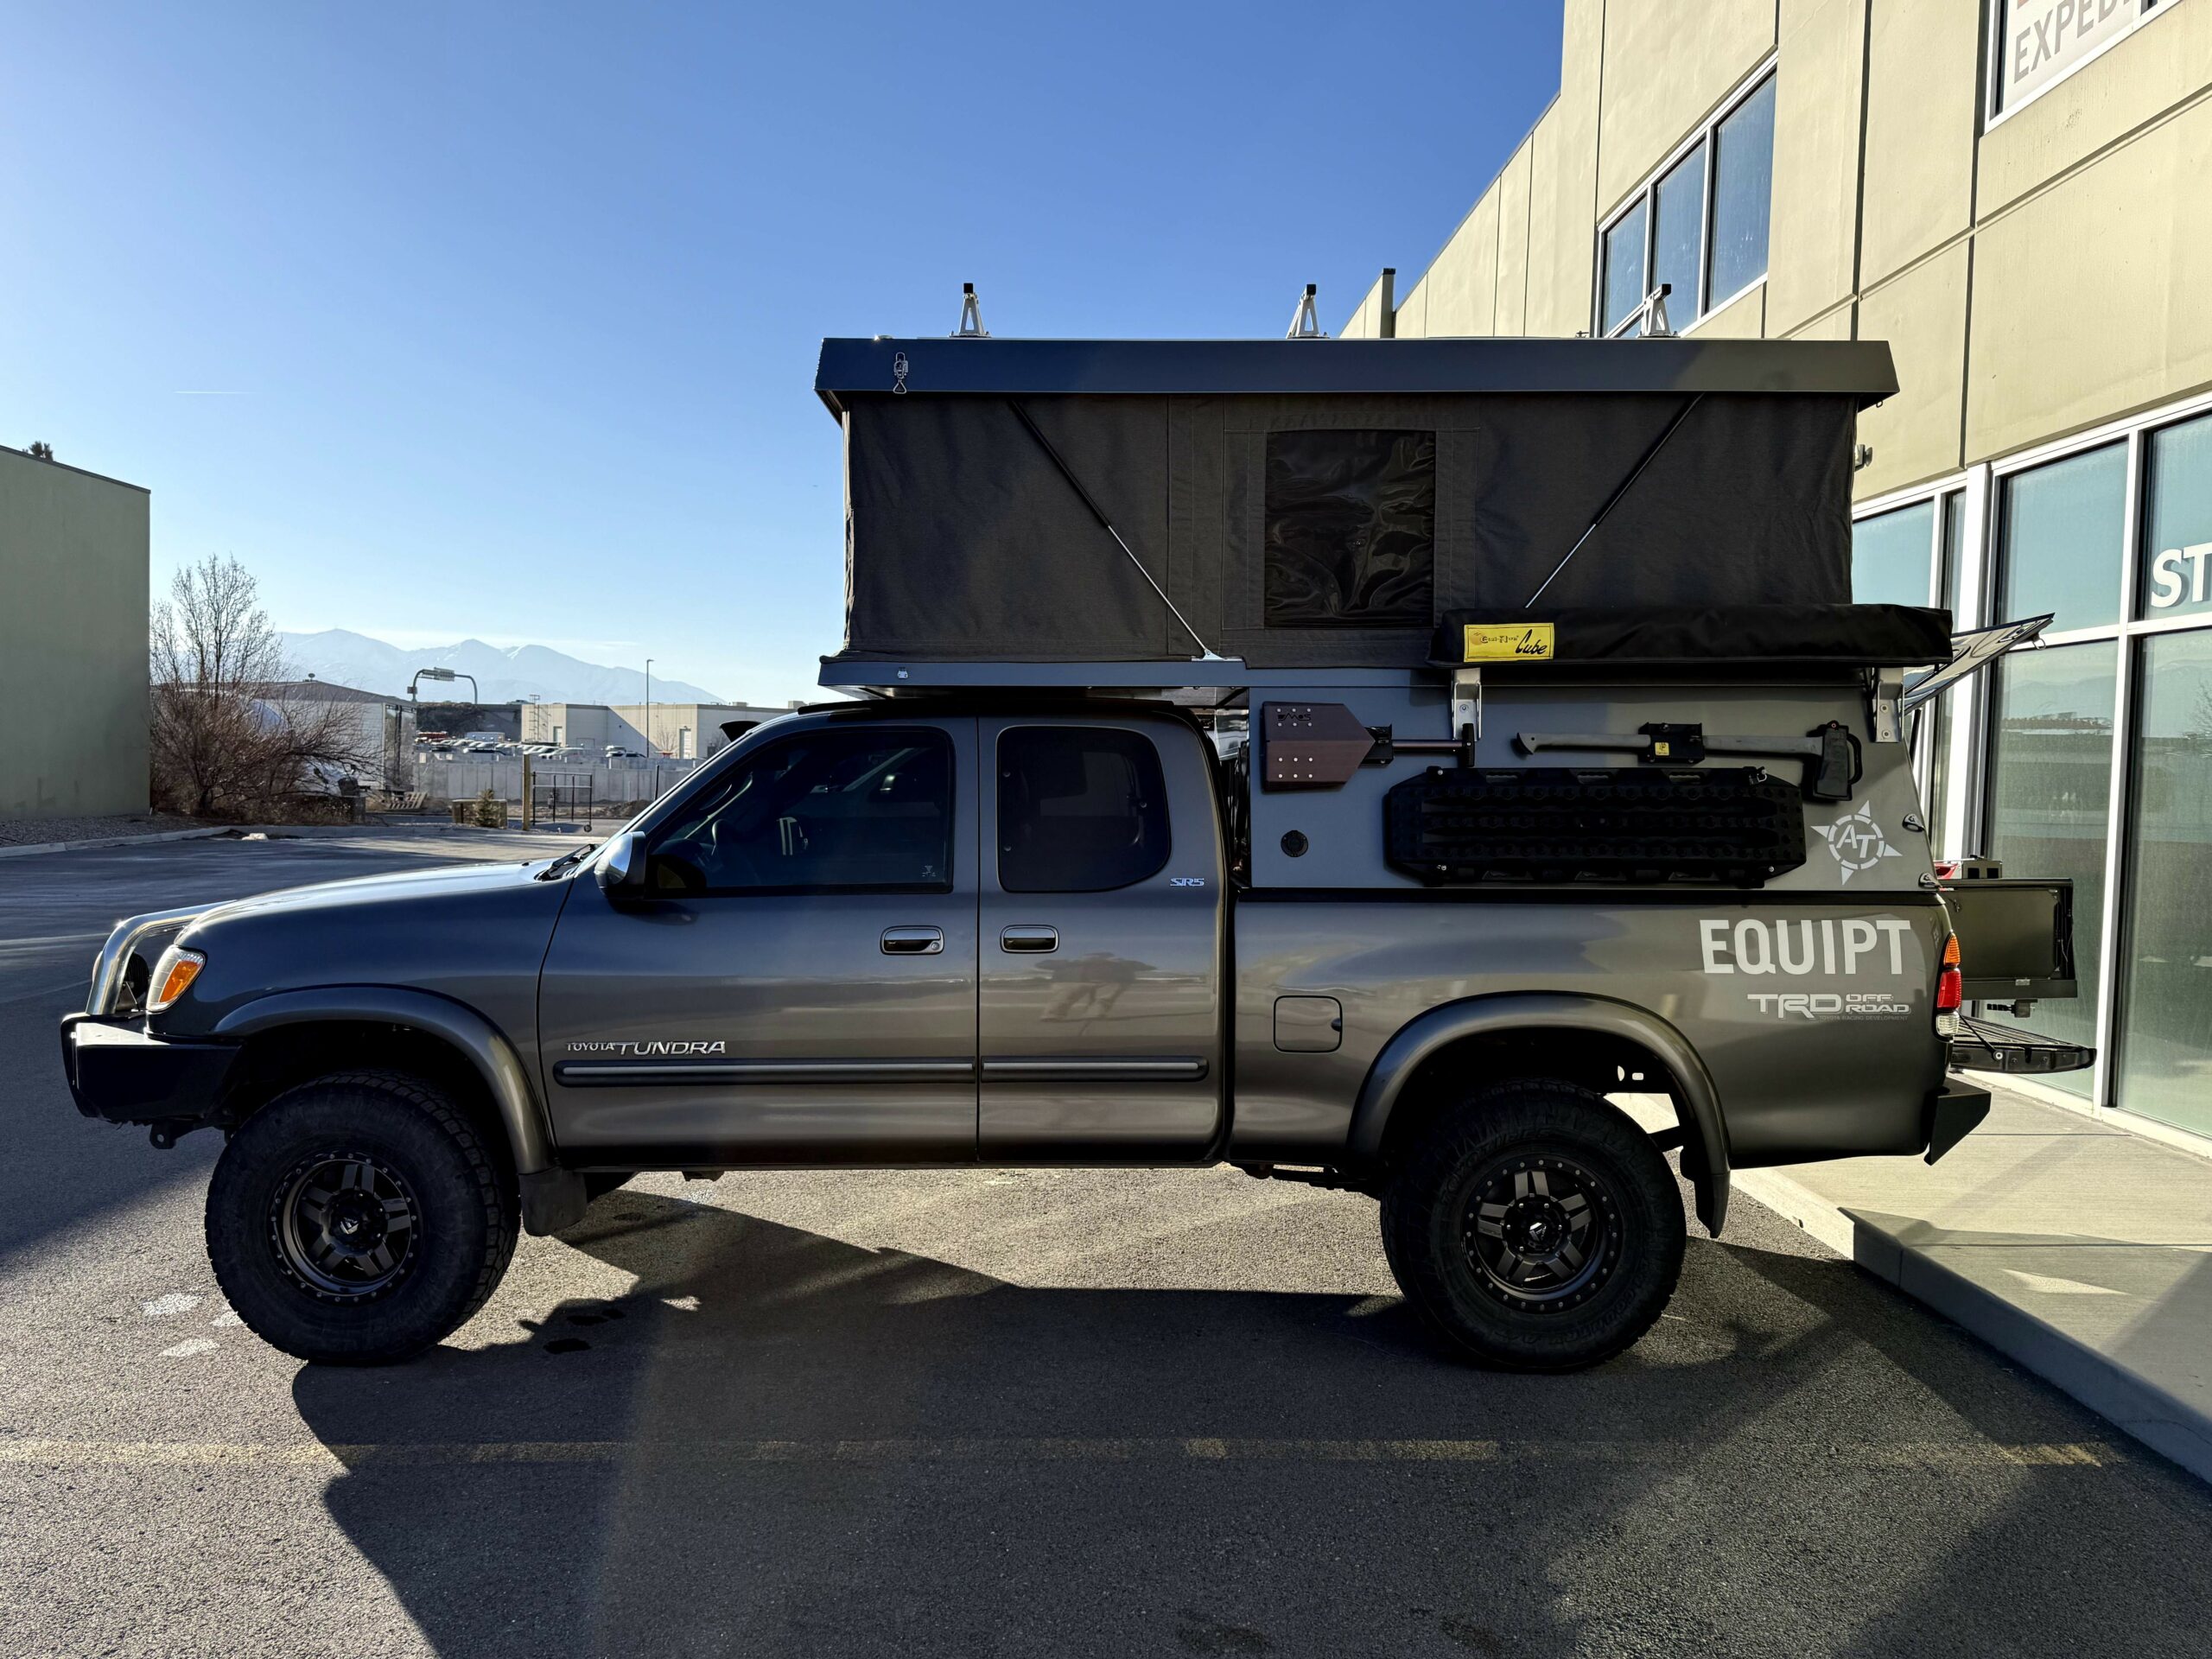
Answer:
0;449;149;818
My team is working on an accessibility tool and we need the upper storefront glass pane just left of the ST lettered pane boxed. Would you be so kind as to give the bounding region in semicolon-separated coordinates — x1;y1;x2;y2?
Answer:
1998;442;2128;632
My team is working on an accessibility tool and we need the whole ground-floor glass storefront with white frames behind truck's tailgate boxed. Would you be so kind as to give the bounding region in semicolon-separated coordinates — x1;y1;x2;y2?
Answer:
1852;400;2212;1139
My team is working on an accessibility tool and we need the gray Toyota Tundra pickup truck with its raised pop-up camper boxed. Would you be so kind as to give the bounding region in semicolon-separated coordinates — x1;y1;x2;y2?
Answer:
62;340;2086;1370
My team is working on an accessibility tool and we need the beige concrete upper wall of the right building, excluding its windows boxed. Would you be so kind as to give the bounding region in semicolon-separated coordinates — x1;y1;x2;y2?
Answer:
1358;0;2212;498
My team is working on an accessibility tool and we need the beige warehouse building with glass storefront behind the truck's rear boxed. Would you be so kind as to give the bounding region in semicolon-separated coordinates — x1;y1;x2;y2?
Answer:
1343;0;2212;1135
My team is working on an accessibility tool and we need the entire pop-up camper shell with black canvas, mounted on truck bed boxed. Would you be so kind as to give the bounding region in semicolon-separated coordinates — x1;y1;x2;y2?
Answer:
817;339;2052;925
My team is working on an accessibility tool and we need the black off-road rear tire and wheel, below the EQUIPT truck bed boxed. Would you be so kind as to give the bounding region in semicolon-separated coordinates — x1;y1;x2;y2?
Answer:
1382;1079;1686;1371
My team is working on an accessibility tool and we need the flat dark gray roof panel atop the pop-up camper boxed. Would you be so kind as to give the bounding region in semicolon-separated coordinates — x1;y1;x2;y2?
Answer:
814;336;1897;416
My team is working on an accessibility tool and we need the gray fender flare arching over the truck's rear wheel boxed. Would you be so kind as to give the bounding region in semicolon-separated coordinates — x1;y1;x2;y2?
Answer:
1347;991;1730;1236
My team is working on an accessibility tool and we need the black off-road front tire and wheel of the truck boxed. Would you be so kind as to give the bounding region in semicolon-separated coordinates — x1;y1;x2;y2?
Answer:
208;1071;518;1365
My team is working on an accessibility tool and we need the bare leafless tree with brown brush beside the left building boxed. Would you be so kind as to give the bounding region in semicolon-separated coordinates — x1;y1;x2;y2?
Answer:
149;553;367;818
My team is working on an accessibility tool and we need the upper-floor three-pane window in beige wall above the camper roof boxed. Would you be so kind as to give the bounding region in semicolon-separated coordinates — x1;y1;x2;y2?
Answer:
1597;73;1774;336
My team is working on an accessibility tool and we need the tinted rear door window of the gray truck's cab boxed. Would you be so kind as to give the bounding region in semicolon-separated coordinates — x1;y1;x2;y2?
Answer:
998;726;1168;893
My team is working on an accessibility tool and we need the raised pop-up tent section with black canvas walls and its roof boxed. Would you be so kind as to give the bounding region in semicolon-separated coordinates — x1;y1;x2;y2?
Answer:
817;339;1896;666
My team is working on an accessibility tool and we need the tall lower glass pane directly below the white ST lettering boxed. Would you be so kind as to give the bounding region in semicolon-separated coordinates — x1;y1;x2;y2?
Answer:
2114;631;2212;1135
